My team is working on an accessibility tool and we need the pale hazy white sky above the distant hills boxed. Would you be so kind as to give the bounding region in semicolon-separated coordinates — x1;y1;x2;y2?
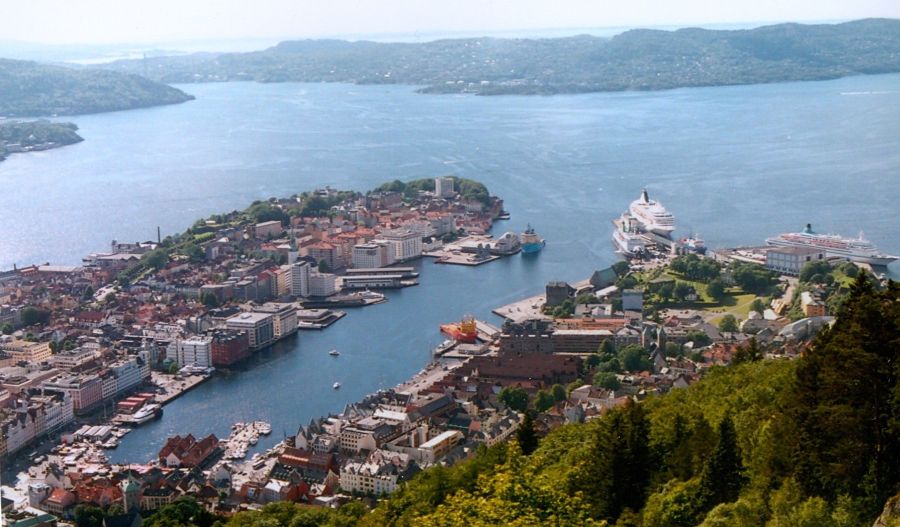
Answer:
7;0;900;44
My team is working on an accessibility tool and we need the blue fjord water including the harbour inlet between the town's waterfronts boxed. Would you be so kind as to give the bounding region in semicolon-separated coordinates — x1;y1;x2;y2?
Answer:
0;75;900;461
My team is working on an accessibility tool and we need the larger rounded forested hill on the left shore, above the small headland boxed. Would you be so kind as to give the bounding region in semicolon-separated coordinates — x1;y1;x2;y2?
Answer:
0;59;194;117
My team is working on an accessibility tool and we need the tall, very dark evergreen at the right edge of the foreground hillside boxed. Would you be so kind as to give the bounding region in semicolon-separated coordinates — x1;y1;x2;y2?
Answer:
787;271;900;516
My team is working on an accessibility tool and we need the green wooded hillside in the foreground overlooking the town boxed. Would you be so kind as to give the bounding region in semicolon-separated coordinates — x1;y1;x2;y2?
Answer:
197;273;900;527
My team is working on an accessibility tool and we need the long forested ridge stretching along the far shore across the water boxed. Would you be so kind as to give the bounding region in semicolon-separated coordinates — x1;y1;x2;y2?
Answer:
107;19;900;95
